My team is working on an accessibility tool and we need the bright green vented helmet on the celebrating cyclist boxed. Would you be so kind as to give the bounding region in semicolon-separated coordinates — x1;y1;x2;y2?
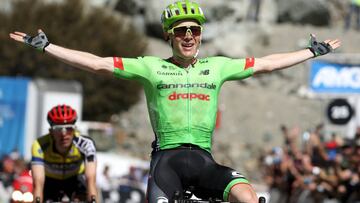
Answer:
161;0;206;31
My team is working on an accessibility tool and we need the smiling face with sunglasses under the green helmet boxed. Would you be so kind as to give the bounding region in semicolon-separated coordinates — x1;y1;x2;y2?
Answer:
169;21;202;60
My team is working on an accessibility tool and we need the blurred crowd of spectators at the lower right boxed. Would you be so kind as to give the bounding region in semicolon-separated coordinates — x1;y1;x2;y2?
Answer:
260;124;360;203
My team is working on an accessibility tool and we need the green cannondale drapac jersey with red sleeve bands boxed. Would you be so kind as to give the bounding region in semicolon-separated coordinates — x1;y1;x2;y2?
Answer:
114;56;255;152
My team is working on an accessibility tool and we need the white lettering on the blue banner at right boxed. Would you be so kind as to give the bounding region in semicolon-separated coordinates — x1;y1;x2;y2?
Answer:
312;66;360;89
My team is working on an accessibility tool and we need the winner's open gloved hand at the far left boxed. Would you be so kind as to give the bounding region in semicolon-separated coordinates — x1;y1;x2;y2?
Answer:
9;29;50;52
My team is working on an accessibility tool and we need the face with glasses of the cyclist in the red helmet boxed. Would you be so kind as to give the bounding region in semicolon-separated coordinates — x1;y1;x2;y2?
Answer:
50;125;75;149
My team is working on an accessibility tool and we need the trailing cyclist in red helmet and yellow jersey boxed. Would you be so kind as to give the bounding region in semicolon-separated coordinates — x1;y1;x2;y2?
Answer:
31;105;97;203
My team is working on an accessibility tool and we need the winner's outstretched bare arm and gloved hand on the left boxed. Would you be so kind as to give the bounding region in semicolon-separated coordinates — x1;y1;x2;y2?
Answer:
9;30;113;75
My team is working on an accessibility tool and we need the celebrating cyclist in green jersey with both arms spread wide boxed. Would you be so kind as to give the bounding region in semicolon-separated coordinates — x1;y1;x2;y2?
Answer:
10;0;340;203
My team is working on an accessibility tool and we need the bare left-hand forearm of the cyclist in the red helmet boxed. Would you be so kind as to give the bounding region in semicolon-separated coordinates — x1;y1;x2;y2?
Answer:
31;165;45;202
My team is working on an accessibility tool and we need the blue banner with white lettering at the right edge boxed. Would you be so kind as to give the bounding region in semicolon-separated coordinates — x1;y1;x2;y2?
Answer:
309;60;360;93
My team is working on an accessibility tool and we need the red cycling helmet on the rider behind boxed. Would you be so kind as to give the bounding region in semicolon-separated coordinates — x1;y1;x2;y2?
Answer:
47;105;77;126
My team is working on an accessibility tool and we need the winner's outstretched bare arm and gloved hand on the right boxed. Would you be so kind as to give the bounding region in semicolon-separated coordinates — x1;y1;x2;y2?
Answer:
253;35;341;74
